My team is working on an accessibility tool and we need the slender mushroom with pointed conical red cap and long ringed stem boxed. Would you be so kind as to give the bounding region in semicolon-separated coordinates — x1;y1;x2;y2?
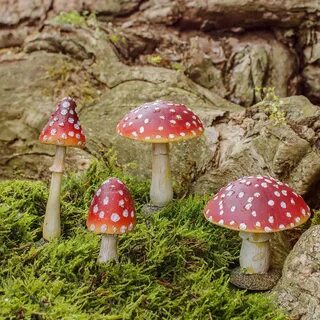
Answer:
39;97;86;241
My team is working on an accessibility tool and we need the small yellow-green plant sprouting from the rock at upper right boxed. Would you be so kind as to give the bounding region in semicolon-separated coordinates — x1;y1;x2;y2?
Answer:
255;87;286;124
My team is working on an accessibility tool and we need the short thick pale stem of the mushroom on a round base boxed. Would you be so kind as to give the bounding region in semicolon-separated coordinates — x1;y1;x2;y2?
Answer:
239;232;271;274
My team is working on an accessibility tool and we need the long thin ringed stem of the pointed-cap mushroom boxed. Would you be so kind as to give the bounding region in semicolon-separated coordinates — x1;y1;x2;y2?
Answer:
43;146;66;241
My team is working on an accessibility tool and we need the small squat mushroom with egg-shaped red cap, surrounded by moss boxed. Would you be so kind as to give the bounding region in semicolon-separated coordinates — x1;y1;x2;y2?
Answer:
87;178;136;263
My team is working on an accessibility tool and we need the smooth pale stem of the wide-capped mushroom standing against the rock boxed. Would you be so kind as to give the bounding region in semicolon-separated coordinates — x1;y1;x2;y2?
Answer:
150;143;173;207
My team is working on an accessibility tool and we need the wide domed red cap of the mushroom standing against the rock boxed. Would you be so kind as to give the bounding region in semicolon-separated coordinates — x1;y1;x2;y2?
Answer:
117;100;203;143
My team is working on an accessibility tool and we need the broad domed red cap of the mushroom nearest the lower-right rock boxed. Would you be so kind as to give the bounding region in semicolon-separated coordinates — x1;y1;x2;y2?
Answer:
204;176;311;233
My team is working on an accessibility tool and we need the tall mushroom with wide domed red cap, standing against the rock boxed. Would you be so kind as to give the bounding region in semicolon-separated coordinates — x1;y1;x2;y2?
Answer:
117;100;203;207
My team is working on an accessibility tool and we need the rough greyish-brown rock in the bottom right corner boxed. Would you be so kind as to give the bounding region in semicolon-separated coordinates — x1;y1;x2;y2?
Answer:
274;226;320;320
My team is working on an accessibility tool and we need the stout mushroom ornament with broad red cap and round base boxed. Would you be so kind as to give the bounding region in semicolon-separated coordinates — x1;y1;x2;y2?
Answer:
204;176;311;290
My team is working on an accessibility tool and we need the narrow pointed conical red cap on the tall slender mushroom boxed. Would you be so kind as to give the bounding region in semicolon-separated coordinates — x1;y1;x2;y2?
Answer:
39;97;86;148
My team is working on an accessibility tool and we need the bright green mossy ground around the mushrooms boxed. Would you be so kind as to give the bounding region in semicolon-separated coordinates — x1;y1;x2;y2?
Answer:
0;159;286;320
